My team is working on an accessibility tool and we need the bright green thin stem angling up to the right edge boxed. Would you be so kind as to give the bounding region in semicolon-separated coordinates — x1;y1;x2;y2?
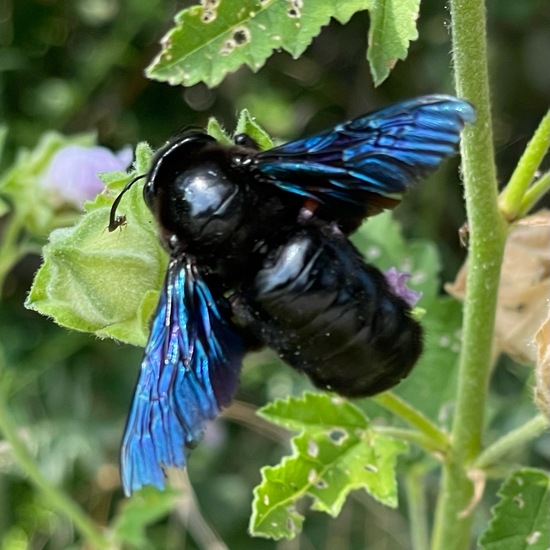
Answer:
500;111;550;221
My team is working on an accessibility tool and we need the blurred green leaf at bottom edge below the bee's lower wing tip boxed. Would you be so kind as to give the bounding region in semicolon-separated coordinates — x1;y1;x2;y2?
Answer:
111;487;178;548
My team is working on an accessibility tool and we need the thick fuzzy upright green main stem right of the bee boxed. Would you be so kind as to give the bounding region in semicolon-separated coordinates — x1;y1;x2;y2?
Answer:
432;0;507;550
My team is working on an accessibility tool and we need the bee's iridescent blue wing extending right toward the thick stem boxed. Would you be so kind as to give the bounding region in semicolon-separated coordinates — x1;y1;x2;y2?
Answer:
255;95;475;215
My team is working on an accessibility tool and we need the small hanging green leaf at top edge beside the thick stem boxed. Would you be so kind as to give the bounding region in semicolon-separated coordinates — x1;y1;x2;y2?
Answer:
367;0;420;86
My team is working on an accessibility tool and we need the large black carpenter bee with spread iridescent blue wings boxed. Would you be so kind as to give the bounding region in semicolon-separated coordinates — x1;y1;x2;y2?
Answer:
109;95;475;494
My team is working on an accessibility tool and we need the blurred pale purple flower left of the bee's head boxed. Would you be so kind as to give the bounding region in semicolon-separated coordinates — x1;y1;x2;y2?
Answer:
41;145;132;209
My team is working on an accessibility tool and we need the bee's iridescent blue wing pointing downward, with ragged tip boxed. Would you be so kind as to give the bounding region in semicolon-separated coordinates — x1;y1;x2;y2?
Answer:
121;256;244;495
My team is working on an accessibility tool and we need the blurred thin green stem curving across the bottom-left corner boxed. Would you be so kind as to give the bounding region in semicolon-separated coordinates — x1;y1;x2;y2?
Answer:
0;388;109;549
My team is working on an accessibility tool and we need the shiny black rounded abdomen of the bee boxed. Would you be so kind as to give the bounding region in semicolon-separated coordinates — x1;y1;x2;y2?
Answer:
233;226;422;397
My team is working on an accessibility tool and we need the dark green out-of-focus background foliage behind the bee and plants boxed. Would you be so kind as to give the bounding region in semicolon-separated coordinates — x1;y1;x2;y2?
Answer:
0;0;550;550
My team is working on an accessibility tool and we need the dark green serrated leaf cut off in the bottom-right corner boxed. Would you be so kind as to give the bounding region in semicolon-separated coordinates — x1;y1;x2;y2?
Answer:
480;468;550;550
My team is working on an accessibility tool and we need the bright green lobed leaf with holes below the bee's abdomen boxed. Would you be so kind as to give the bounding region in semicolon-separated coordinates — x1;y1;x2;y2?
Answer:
250;393;407;539
